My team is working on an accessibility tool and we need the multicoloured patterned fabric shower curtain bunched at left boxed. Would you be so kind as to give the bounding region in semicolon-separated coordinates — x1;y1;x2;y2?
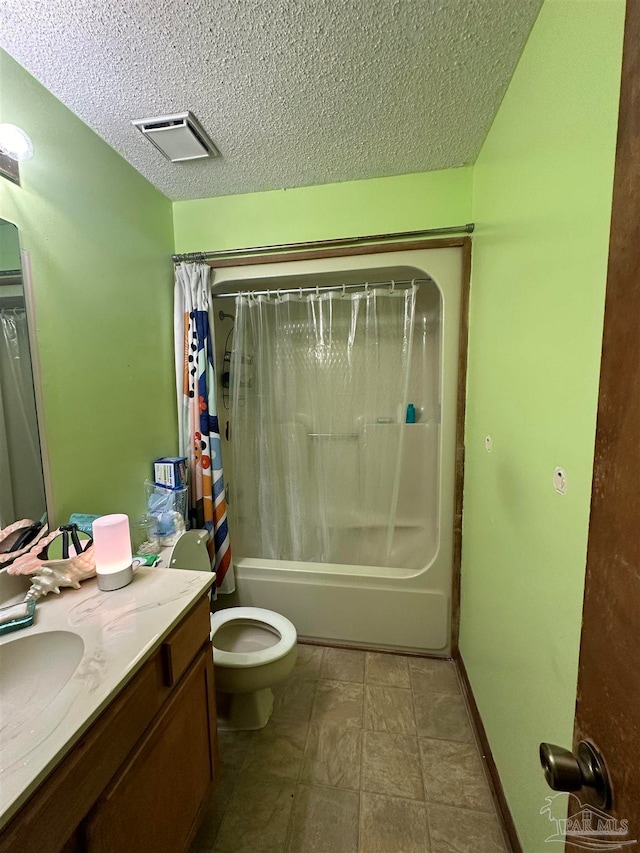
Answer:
174;263;235;593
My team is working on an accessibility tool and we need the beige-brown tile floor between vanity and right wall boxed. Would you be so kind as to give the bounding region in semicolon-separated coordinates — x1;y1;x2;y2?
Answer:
190;645;509;853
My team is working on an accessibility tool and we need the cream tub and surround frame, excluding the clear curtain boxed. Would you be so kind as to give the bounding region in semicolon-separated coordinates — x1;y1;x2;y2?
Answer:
213;244;468;657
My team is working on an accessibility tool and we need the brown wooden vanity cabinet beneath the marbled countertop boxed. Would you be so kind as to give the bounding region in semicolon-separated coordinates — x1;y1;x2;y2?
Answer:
0;596;218;853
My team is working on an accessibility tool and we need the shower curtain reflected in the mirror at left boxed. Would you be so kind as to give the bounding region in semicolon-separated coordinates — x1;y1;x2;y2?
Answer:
0;308;45;528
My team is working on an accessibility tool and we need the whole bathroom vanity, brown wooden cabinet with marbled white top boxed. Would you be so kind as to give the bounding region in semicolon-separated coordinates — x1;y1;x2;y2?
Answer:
0;569;217;853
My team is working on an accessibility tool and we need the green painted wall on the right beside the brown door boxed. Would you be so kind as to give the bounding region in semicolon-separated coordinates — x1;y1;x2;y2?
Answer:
461;0;624;853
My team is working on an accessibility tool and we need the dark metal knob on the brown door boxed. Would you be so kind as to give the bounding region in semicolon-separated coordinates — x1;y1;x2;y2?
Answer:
540;740;611;809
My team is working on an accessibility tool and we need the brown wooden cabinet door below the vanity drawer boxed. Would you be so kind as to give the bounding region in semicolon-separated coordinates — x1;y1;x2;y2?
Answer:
85;647;216;853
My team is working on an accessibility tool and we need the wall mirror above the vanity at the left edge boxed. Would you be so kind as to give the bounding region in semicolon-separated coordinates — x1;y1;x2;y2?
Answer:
0;219;46;528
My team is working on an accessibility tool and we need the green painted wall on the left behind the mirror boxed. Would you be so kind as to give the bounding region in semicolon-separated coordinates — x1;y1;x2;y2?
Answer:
0;51;177;521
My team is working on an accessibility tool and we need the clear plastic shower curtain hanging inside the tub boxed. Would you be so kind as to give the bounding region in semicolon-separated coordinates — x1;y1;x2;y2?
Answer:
230;286;415;566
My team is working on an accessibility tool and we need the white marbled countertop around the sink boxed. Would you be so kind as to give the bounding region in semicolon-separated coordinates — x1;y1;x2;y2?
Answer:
0;568;215;827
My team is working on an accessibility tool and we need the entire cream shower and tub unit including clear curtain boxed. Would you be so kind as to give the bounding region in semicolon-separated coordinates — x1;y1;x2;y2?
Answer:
212;247;463;656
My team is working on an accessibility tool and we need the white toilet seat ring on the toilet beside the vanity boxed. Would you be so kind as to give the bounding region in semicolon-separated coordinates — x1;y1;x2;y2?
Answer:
211;607;298;669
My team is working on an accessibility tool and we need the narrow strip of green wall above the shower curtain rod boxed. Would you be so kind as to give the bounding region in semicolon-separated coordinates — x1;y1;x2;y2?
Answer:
173;167;472;252
